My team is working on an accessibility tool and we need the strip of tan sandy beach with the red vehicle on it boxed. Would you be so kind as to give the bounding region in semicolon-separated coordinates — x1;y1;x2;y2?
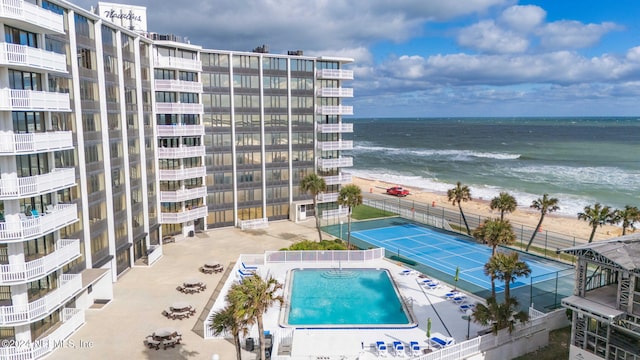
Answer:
353;176;630;241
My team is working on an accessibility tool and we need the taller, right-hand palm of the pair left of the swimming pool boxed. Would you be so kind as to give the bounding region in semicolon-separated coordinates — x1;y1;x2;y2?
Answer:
227;274;283;359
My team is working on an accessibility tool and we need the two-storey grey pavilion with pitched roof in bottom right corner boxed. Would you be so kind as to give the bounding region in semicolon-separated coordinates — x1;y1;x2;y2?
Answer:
562;234;640;360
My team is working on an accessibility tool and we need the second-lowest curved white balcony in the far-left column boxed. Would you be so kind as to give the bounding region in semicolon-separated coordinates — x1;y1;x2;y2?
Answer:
0;274;82;326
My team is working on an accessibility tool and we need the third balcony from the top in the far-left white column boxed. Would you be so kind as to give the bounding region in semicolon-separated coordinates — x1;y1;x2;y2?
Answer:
0;89;71;112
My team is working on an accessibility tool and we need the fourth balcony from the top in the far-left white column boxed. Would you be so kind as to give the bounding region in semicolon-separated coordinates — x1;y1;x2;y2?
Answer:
0;131;74;155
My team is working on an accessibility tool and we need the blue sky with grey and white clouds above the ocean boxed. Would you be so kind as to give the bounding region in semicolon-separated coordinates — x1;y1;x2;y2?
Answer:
72;0;640;117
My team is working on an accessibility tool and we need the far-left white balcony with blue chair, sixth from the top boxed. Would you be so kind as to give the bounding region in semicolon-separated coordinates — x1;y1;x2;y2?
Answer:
0;204;78;243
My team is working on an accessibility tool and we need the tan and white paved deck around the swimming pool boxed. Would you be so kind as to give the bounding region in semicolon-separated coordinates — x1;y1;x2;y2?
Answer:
47;219;488;360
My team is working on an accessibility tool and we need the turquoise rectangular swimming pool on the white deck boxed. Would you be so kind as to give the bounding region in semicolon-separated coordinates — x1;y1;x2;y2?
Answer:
280;268;417;328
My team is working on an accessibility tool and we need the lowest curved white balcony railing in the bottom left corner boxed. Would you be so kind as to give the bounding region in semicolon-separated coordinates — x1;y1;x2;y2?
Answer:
0;308;85;360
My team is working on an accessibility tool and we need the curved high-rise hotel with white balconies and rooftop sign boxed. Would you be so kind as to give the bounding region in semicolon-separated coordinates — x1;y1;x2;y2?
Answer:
0;0;353;359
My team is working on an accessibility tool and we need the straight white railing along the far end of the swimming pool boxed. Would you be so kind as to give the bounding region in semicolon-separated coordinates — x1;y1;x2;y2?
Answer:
264;248;384;264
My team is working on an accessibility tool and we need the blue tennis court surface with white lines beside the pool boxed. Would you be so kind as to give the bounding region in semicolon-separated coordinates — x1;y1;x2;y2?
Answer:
351;224;569;292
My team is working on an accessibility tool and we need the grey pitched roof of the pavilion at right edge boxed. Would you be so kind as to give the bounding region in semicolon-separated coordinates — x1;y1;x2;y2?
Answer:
560;233;640;273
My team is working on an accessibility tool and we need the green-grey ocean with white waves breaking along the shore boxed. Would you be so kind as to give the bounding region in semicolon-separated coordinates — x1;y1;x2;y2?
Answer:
344;117;640;217
